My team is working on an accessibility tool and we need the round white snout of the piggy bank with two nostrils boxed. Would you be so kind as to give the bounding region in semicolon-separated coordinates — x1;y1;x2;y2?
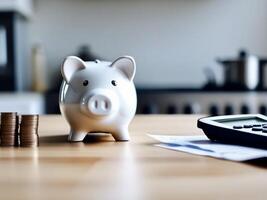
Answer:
82;89;118;116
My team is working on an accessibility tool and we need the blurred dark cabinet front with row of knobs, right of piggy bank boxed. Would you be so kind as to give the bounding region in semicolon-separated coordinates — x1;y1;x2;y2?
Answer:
137;89;267;115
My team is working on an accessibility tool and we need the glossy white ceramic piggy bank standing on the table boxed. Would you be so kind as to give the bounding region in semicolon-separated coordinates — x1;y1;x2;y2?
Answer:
59;56;137;141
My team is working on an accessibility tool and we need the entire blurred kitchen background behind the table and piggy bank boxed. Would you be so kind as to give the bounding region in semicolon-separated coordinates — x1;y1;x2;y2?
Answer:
0;0;267;115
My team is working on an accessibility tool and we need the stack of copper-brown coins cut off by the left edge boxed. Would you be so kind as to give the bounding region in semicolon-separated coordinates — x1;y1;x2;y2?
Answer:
1;113;18;146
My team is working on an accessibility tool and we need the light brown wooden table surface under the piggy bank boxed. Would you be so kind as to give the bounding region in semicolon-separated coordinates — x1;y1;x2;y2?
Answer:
0;115;267;200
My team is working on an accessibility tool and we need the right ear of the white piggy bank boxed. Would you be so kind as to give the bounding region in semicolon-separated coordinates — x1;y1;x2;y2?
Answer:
111;56;136;81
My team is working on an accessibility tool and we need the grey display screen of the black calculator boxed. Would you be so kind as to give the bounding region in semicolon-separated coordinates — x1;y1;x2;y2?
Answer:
215;117;267;126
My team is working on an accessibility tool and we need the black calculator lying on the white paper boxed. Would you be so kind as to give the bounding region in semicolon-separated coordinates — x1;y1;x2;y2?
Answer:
197;114;267;149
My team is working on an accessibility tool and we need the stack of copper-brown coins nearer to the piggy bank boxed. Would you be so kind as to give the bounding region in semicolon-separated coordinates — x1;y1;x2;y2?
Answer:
19;115;39;147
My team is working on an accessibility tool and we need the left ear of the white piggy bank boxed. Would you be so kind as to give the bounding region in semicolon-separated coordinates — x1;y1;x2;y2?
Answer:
61;56;86;83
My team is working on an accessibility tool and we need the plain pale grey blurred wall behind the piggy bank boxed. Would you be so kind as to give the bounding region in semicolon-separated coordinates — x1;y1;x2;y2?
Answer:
31;0;267;87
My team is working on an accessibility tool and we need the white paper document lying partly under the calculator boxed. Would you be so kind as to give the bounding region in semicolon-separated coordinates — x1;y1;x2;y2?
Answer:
148;134;267;161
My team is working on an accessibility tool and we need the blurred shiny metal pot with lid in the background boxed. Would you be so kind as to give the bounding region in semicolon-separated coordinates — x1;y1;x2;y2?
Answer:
217;51;267;90
